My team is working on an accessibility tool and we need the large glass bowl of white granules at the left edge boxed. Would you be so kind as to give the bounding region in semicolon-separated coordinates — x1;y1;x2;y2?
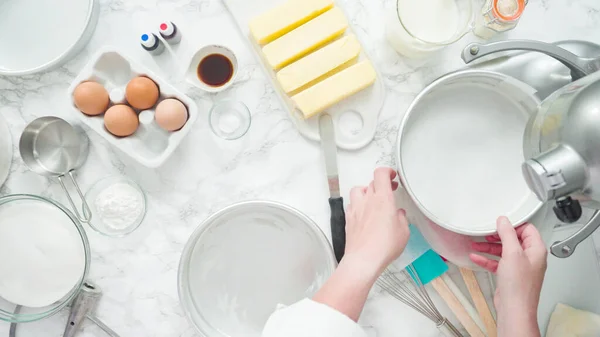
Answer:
0;194;90;323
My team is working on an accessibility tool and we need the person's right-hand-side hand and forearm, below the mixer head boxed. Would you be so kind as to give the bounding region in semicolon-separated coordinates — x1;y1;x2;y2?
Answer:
470;217;548;337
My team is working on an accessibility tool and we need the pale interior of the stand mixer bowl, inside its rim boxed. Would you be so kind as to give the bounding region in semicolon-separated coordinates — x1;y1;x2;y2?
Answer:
401;85;535;231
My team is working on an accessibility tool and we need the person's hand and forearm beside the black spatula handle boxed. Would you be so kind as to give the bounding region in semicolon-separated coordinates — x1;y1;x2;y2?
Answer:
313;168;410;321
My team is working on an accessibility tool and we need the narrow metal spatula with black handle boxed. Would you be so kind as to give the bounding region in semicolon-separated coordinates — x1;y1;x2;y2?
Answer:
319;114;346;263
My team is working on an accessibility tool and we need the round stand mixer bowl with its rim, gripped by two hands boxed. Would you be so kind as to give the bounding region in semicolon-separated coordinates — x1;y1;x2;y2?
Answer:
397;70;542;236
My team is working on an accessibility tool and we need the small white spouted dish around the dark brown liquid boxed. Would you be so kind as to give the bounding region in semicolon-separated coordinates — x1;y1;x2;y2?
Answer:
185;45;238;93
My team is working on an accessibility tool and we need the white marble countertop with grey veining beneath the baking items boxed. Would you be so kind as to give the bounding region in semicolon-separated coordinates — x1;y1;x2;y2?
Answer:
0;0;600;337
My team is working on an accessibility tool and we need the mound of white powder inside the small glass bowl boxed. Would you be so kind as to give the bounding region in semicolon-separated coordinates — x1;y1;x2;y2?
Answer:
94;183;144;230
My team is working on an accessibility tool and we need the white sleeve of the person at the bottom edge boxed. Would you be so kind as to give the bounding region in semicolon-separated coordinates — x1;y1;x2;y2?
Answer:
262;299;367;337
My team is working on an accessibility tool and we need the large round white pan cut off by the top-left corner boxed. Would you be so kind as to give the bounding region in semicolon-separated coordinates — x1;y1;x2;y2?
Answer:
0;0;100;76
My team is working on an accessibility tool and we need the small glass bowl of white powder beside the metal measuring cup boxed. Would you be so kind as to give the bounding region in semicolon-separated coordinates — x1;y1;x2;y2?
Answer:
85;176;146;237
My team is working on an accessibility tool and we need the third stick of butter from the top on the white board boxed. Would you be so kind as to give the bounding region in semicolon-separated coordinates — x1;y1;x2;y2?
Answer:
277;35;360;94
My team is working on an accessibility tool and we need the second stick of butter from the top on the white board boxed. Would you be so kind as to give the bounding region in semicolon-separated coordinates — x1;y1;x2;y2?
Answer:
263;7;348;69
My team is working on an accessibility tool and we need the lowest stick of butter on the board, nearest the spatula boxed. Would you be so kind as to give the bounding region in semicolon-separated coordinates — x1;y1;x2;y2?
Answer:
292;61;377;118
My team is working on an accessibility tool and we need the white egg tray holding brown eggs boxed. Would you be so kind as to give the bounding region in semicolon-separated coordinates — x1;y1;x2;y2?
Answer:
68;47;198;168
